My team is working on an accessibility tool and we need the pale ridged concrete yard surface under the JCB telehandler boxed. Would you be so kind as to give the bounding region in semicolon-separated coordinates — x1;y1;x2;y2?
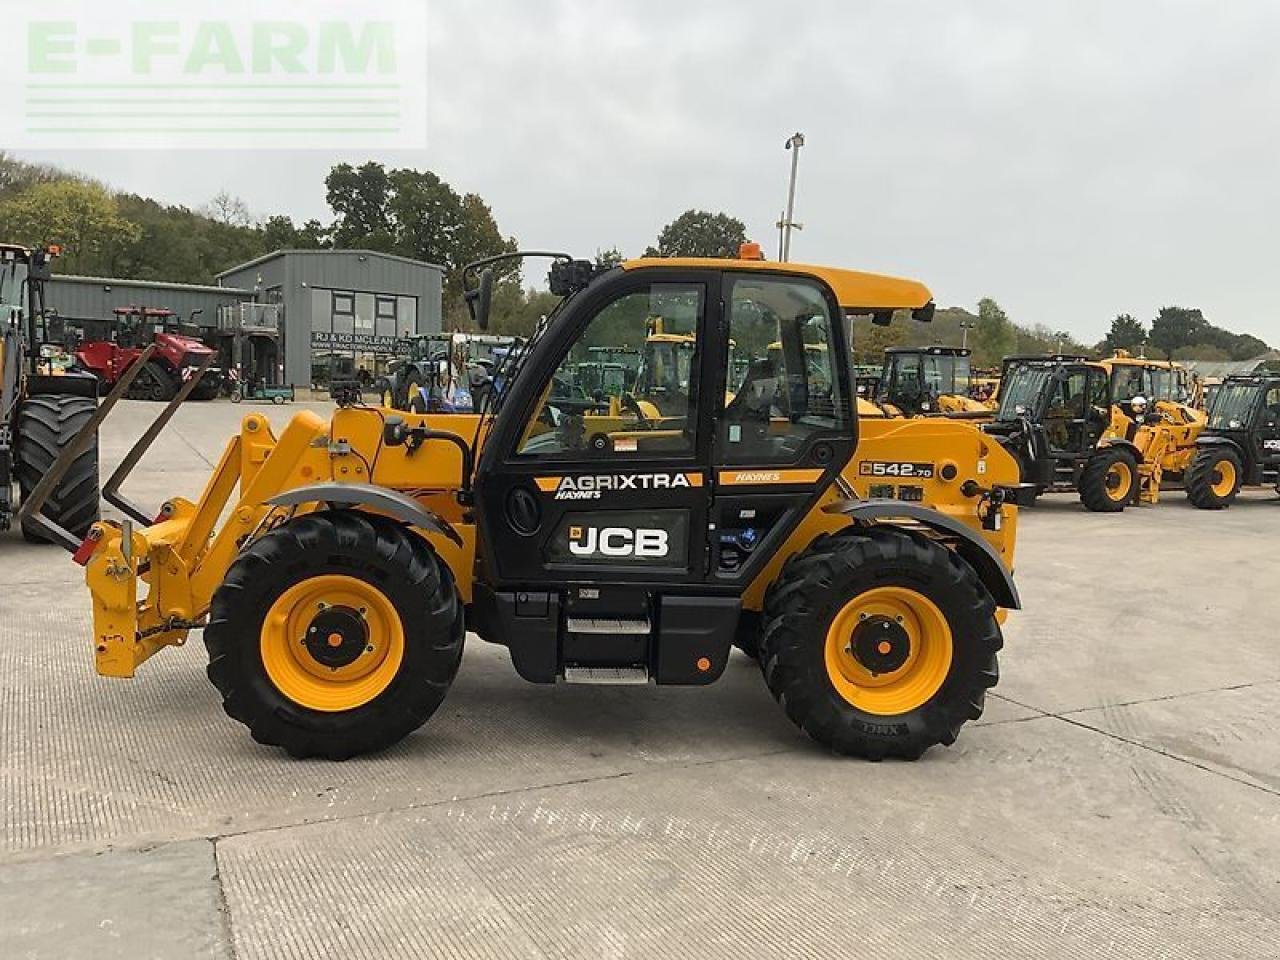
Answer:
0;402;1280;960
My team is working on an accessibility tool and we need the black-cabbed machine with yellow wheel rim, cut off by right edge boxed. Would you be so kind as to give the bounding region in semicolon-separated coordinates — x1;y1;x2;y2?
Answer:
1187;374;1280;509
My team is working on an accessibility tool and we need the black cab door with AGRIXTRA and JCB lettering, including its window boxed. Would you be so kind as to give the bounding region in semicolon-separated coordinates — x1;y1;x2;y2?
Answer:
477;270;721;588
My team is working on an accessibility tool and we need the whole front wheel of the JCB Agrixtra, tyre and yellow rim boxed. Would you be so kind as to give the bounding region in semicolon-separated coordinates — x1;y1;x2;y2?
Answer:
205;511;465;760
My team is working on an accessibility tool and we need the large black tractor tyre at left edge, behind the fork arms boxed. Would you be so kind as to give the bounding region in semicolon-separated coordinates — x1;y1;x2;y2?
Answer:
14;394;101;543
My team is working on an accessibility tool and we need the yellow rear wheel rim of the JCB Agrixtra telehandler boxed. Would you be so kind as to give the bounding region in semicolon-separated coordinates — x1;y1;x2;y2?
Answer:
826;586;952;717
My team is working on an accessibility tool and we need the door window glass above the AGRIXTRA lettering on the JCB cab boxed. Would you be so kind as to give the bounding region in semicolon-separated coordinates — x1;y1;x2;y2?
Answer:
517;283;703;460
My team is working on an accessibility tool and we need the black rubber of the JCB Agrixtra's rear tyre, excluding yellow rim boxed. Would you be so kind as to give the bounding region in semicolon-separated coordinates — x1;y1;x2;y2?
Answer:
760;529;1004;760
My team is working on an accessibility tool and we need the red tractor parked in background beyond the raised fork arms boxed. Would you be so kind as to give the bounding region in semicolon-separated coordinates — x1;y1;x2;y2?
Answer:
76;306;219;401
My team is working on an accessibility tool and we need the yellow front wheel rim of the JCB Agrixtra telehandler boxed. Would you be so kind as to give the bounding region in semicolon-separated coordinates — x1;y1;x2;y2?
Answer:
260;575;404;713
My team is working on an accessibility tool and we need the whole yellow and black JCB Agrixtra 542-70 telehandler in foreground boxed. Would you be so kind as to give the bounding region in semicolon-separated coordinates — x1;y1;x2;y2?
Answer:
67;253;1021;759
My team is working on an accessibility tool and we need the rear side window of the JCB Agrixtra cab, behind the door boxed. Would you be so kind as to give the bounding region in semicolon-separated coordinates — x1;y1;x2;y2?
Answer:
717;275;851;463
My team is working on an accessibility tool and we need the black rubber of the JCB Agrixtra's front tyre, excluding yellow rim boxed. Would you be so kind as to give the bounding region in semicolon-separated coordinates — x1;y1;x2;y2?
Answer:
205;511;465;760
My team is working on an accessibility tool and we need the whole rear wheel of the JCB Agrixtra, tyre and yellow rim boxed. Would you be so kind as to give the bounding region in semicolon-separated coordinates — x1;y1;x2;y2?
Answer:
759;529;1002;760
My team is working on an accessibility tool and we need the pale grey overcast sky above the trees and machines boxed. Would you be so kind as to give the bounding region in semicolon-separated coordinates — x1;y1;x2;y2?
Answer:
12;0;1280;343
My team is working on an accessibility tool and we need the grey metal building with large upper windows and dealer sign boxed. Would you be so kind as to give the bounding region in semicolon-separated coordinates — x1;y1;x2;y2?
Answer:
218;250;444;387
